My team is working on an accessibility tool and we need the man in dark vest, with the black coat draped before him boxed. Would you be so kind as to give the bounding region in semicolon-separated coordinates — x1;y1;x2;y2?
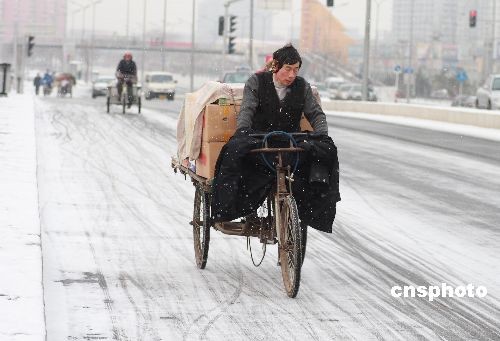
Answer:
211;44;340;232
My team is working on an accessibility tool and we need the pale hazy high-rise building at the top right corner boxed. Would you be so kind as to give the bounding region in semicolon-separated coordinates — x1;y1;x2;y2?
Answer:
392;0;500;81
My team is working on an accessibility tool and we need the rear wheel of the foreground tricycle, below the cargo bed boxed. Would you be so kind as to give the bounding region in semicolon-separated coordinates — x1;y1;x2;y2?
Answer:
193;186;210;269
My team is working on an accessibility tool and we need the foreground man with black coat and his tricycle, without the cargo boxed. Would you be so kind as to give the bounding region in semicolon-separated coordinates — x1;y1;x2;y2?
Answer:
174;45;340;297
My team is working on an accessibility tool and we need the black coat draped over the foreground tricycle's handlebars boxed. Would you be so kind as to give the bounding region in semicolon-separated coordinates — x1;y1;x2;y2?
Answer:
211;132;340;232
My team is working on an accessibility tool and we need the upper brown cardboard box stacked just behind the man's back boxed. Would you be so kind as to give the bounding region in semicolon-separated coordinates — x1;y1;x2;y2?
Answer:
201;104;240;142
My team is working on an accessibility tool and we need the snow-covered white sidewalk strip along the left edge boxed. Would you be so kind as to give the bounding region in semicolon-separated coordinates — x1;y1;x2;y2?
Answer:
0;91;45;341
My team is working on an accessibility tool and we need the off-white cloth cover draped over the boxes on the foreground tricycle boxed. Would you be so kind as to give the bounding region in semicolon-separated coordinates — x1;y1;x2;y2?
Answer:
177;81;244;161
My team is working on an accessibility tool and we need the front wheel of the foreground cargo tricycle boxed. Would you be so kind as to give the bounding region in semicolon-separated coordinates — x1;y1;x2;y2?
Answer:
278;196;302;298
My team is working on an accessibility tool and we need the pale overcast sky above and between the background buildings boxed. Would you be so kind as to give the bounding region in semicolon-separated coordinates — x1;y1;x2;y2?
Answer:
68;0;393;39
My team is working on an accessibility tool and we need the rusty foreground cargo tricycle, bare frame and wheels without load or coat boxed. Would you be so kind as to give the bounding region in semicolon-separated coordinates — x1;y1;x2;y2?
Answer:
172;131;307;298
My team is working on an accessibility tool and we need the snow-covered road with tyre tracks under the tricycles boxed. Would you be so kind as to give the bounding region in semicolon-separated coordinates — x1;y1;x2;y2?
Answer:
36;93;500;341
